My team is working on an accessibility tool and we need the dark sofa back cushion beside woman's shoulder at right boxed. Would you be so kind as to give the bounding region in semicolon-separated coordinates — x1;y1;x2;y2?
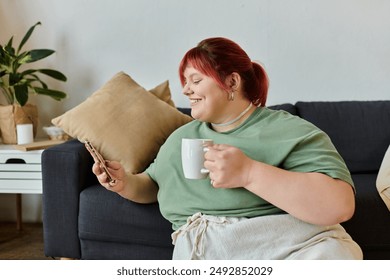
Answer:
296;101;390;173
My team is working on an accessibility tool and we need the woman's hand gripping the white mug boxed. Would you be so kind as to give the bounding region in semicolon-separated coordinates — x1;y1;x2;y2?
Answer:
204;144;253;188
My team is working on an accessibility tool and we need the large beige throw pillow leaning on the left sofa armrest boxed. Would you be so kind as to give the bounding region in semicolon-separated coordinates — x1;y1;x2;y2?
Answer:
52;72;192;173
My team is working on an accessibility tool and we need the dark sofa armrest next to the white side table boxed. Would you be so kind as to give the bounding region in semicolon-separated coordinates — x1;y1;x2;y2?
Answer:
42;140;97;258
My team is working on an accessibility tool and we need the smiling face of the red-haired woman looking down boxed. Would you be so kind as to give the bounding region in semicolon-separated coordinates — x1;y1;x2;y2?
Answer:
183;65;229;122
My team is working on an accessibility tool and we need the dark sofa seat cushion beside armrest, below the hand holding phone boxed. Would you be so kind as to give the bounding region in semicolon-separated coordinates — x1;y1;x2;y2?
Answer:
79;185;172;248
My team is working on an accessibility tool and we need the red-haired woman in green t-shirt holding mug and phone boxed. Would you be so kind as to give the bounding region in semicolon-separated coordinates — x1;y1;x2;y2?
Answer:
93;38;362;259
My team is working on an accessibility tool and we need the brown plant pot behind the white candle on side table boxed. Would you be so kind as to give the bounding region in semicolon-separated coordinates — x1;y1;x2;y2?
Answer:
0;104;38;144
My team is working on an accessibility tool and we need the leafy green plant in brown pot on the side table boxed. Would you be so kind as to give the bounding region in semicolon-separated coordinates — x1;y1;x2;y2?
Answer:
0;22;66;144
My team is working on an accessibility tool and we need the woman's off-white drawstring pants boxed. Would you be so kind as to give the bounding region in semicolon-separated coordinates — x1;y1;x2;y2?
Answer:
172;213;363;260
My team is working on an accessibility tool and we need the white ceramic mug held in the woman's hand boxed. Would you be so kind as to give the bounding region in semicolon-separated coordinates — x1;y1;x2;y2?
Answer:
181;138;213;179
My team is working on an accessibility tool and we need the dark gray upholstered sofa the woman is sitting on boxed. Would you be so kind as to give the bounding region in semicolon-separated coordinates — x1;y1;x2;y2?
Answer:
42;101;390;259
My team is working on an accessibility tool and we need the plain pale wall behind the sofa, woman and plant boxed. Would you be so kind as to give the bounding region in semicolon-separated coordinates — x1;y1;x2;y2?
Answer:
0;0;390;223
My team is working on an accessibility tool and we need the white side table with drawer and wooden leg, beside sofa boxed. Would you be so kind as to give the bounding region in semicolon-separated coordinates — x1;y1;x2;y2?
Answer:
0;145;43;230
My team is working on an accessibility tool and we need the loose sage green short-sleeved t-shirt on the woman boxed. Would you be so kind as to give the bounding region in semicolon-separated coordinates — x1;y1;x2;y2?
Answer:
146;107;353;230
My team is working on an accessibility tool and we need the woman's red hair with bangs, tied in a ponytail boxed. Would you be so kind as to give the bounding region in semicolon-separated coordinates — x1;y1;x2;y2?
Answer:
179;37;269;106
